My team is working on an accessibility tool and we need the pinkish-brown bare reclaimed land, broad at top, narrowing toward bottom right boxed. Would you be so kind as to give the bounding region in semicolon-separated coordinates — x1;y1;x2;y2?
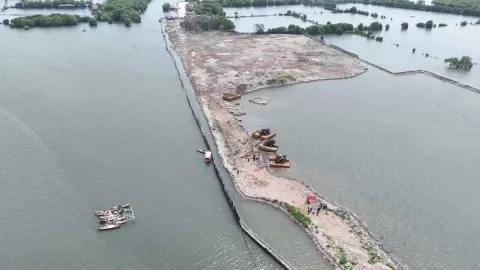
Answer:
167;21;404;270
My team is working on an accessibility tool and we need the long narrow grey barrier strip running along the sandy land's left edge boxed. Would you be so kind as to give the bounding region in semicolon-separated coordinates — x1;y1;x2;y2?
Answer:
161;20;295;270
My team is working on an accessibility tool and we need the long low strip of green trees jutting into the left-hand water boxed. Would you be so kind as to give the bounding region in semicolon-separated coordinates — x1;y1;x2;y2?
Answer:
10;14;93;28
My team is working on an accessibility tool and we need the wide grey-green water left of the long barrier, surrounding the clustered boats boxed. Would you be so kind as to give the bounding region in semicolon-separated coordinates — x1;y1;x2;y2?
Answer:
0;1;288;270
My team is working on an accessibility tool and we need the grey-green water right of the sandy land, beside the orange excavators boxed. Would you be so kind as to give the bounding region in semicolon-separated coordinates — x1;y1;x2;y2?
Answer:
241;69;480;269
